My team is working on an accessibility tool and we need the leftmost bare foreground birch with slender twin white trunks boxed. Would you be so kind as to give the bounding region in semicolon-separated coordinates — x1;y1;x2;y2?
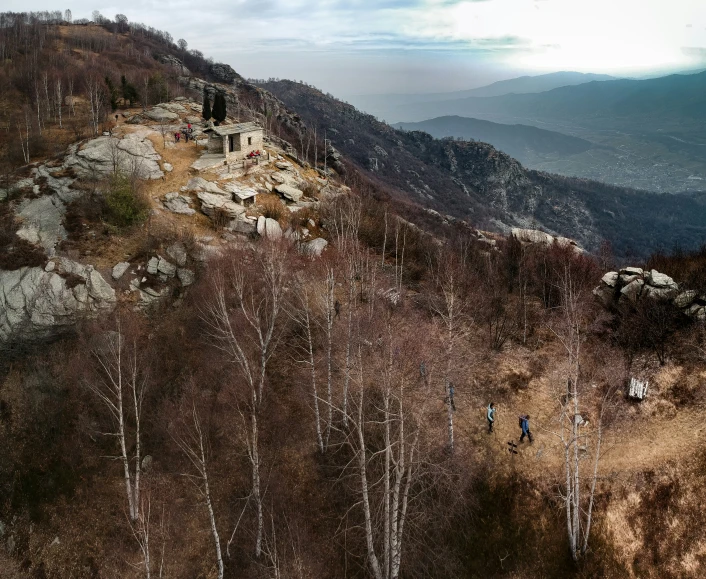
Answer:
87;321;146;521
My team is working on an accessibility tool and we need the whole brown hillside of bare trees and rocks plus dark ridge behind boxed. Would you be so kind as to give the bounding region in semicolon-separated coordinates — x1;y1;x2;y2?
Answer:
0;13;706;579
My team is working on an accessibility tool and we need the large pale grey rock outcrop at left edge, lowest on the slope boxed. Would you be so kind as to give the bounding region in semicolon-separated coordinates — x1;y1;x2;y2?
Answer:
0;258;116;349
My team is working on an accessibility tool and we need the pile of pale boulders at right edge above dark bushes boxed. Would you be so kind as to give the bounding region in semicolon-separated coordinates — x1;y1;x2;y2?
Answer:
593;267;706;320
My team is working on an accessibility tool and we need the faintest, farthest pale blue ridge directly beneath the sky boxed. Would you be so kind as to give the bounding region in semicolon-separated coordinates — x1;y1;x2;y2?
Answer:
347;72;615;120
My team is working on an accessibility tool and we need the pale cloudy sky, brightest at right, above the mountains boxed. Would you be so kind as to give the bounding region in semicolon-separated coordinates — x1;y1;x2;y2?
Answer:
9;0;706;96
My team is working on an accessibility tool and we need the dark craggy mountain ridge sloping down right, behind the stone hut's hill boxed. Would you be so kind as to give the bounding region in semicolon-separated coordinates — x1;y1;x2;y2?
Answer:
259;81;706;255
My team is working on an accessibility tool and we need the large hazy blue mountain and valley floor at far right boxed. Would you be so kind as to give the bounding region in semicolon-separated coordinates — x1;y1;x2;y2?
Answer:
364;72;706;193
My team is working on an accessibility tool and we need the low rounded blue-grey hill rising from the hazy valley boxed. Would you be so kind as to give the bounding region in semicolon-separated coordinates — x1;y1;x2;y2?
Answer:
394;116;597;166
